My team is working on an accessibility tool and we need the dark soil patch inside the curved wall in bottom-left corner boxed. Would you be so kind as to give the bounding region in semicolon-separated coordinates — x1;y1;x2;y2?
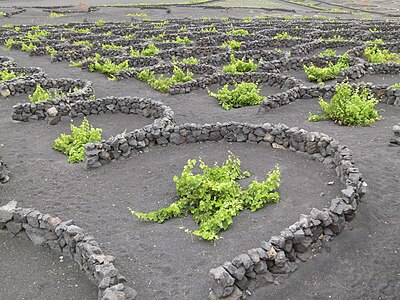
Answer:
0;231;97;300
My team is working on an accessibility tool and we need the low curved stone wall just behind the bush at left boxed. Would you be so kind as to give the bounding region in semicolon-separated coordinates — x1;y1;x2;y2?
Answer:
12;97;174;122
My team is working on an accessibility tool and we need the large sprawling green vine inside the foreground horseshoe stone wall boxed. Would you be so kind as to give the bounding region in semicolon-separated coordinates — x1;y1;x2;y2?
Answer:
130;154;280;240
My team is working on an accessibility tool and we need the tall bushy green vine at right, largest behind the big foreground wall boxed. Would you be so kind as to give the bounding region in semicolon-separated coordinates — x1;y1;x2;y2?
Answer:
308;81;379;126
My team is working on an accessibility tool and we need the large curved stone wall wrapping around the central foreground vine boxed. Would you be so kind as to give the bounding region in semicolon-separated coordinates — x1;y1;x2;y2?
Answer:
85;122;366;299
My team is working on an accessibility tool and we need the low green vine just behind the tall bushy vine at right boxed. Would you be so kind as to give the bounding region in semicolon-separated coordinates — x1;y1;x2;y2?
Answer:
303;54;350;83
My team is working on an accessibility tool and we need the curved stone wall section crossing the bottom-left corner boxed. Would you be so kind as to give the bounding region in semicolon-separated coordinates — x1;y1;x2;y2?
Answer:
0;201;136;300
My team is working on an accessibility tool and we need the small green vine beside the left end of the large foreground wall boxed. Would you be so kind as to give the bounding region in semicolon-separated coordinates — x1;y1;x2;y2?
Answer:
53;118;102;163
